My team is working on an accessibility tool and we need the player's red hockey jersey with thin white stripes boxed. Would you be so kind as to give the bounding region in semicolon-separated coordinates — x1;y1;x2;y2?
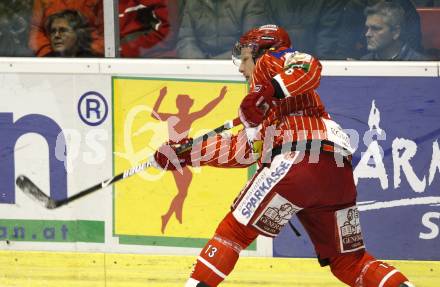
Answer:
192;48;351;167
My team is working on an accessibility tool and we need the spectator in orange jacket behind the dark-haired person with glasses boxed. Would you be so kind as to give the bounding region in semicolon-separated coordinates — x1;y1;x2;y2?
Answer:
29;0;104;56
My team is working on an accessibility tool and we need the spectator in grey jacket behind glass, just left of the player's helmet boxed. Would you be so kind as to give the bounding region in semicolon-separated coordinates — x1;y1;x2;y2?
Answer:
177;0;268;59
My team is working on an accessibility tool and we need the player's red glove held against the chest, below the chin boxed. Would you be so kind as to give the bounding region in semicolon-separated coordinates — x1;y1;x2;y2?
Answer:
238;82;279;128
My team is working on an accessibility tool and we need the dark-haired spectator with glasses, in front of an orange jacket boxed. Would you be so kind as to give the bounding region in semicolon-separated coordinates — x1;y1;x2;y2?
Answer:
45;10;96;57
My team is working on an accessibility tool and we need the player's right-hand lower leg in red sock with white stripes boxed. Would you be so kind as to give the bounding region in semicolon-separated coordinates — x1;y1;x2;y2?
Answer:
330;251;413;287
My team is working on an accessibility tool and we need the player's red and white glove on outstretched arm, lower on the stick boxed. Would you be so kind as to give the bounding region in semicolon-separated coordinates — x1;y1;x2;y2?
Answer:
154;138;192;170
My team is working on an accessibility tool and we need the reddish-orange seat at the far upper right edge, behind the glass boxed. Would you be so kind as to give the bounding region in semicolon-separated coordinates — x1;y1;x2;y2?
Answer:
417;7;440;50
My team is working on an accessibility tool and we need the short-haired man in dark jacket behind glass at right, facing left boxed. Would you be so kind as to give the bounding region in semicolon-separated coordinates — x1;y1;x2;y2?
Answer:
361;2;427;61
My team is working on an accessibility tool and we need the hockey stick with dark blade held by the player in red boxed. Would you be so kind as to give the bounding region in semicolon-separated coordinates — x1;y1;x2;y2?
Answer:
16;118;240;209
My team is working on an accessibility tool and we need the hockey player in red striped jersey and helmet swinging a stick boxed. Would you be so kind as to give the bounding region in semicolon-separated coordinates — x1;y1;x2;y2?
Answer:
155;25;413;287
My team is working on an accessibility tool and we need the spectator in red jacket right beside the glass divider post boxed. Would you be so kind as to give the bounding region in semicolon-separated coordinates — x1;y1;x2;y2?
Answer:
119;0;179;58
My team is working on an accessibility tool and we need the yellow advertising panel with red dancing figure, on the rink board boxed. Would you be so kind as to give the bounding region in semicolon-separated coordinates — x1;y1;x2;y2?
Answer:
113;77;251;247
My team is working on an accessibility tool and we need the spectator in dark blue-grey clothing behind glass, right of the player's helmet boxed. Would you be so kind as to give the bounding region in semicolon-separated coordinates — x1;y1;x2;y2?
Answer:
269;0;346;60
